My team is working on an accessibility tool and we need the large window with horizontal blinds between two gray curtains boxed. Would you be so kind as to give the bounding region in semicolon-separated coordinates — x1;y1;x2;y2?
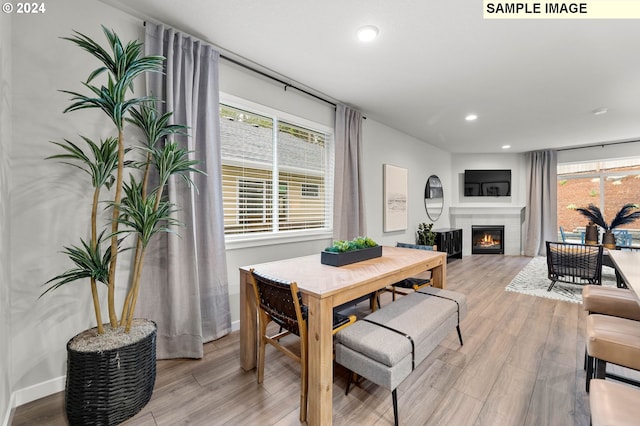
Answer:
220;97;333;238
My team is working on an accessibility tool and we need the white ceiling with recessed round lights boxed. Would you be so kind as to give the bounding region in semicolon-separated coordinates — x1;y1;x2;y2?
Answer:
105;0;640;153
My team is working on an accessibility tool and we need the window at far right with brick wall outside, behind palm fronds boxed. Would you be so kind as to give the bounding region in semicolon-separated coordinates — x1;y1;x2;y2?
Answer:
558;158;640;242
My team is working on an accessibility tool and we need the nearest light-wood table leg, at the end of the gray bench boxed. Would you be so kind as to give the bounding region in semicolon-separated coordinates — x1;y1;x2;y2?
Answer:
307;295;333;426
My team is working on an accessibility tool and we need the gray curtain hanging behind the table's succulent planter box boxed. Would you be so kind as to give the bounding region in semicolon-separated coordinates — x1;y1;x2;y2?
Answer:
333;105;366;240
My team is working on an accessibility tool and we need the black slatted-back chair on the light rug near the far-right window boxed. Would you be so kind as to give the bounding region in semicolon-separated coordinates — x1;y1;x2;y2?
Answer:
546;241;602;291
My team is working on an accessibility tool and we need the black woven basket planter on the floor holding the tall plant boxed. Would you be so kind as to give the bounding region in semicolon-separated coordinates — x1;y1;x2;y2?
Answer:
65;321;157;425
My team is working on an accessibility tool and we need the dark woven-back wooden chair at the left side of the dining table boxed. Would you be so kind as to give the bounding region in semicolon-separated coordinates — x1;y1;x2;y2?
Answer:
250;269;356;422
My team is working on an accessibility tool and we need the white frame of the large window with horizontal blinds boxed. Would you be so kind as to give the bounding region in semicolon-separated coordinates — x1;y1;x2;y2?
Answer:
219;92;335;250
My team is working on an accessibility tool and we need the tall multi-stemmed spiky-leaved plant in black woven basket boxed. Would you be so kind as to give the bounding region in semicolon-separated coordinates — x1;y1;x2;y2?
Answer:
43;27;199;425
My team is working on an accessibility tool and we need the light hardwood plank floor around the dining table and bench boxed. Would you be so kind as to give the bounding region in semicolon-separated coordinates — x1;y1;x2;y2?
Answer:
12;255;589;426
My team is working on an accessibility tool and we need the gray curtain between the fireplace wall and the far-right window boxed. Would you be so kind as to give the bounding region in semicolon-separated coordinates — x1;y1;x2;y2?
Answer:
524;151;558;256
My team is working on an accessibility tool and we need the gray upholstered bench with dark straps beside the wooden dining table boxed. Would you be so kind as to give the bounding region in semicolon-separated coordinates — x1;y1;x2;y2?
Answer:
335;287;467;425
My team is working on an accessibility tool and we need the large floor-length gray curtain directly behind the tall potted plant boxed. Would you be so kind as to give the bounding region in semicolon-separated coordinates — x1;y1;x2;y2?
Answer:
137;23;231;358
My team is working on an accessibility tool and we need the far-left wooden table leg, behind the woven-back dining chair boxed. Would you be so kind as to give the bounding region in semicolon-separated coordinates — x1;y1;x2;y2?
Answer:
240;270;258;371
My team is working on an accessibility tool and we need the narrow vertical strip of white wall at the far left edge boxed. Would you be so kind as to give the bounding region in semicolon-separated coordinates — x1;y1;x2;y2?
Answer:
0;7;12;424
